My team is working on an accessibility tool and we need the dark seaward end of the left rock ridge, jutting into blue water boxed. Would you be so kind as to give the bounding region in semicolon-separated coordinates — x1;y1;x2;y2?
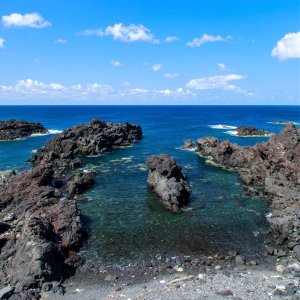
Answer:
31;119;143;169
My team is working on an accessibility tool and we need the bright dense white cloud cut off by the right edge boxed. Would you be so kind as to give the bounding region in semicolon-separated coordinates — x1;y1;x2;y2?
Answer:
271;32;300;60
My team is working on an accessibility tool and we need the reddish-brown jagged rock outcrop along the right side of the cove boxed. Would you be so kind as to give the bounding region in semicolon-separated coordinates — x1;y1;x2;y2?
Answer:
196;123;300;250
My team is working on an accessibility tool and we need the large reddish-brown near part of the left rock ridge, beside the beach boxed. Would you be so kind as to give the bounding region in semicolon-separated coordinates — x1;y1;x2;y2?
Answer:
0;165;83;299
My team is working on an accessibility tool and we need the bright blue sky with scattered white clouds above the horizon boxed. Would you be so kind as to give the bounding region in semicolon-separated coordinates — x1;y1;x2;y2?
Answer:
0;0;300;105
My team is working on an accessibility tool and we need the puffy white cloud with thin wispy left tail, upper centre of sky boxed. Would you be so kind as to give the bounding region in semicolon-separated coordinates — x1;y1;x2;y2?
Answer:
81;23;159;44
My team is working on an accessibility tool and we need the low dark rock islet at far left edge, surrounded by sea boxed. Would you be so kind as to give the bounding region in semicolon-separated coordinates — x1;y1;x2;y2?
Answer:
0;120;48;141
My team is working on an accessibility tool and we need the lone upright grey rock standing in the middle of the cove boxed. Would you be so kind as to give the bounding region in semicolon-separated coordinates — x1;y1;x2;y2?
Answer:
146;154;191;212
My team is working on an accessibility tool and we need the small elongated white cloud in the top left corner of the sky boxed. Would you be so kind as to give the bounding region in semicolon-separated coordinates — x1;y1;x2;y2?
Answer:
2;13;51;28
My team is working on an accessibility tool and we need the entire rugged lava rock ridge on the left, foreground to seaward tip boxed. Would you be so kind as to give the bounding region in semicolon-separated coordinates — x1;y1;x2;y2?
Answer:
0;120;142;299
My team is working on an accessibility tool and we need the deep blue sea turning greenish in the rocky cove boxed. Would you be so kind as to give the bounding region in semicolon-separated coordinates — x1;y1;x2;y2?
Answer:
0;106;300;264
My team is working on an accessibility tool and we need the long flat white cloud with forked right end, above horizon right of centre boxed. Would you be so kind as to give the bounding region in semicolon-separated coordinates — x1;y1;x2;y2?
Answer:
186;74;244;92
